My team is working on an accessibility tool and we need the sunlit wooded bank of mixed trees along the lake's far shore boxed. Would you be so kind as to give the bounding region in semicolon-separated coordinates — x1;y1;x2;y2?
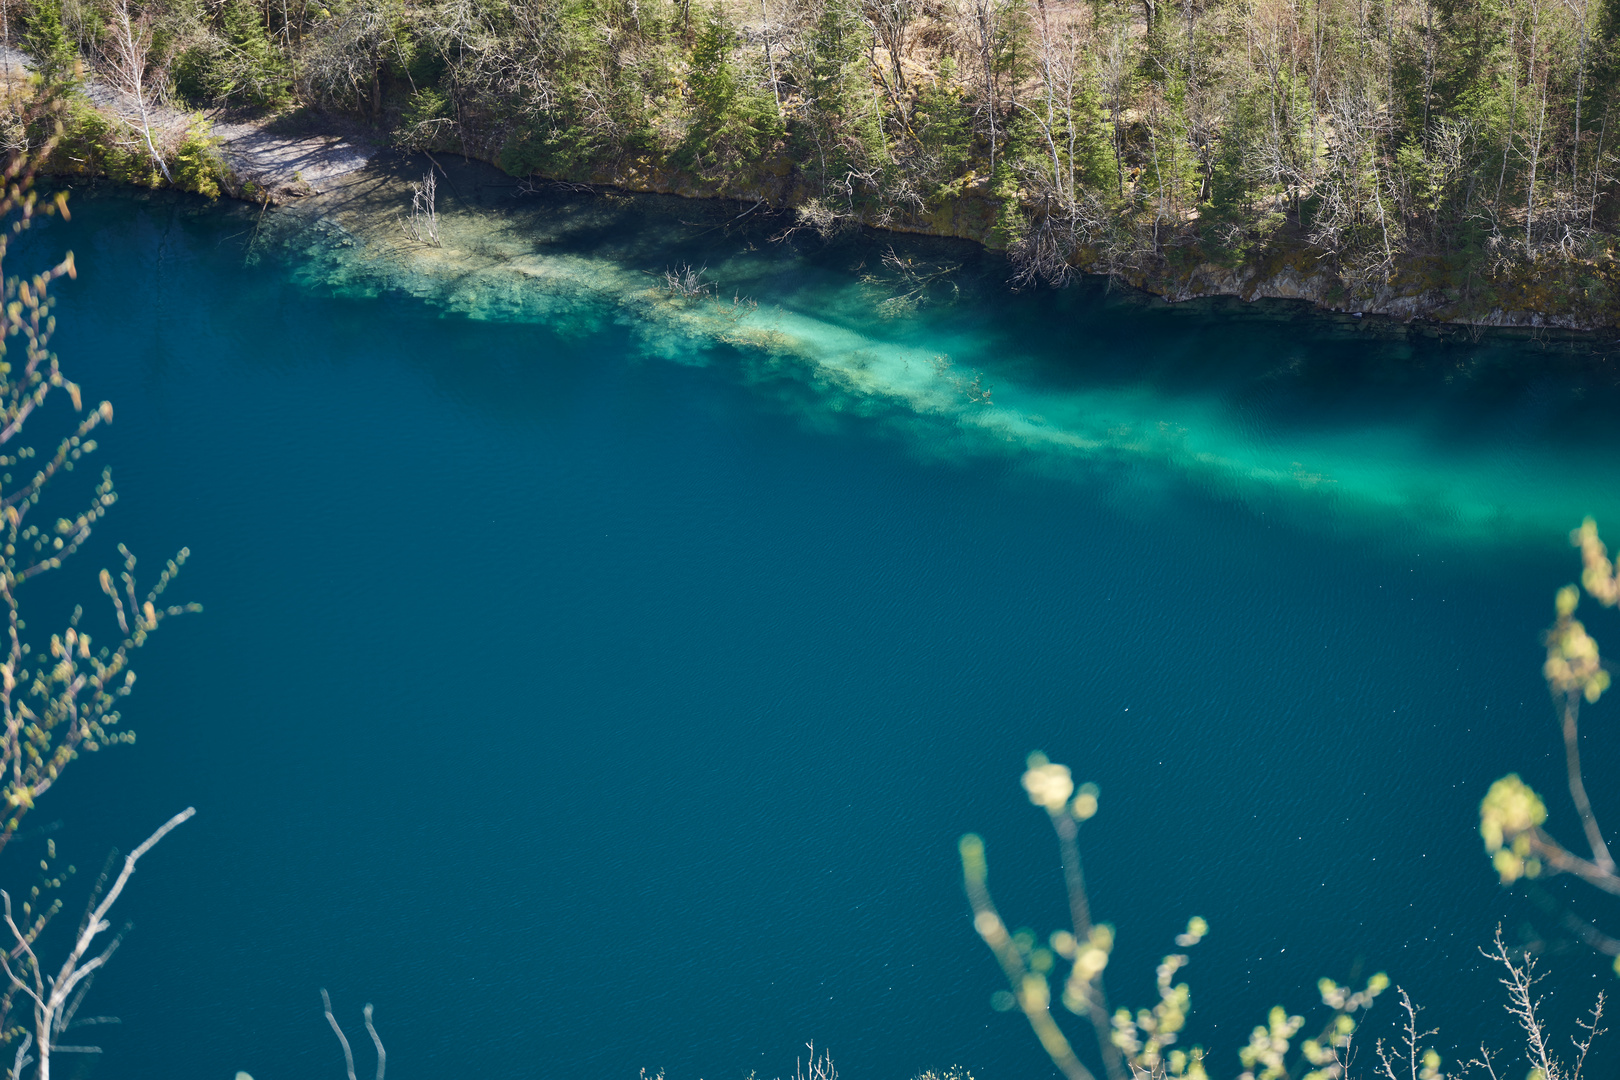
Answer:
8;0;1620;329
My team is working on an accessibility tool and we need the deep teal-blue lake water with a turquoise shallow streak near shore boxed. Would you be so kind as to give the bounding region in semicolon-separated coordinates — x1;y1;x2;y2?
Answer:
8;168;1620;1080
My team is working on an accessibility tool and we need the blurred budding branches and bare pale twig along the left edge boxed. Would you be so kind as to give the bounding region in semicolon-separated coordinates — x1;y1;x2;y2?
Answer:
0;145;201;1080
